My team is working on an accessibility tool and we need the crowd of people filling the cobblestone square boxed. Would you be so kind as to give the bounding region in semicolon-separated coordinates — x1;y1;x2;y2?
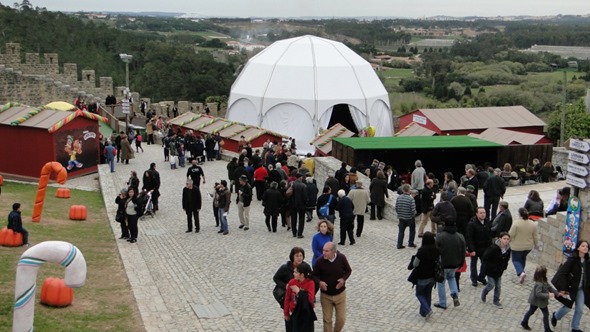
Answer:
99;124;590;331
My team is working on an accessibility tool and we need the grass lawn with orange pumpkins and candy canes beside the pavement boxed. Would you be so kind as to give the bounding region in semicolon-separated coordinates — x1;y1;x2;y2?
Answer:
0;182;143;331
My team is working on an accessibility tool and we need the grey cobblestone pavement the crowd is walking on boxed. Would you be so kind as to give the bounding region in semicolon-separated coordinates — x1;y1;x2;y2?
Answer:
93;145;589;332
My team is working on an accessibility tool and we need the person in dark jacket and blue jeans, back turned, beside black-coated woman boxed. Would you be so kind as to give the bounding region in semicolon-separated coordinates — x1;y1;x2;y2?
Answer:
434;218;467;309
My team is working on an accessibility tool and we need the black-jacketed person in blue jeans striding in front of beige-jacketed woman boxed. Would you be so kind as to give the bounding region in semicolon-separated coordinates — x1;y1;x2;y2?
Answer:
481;232;511;309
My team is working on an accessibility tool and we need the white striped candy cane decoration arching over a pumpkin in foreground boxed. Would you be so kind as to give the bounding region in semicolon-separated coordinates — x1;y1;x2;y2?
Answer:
12;241;86;332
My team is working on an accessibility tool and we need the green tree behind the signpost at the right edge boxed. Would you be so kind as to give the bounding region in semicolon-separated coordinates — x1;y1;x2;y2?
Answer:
547;99;590;141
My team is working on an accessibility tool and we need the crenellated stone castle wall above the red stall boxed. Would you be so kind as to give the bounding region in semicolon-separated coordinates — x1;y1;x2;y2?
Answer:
0;43;113;106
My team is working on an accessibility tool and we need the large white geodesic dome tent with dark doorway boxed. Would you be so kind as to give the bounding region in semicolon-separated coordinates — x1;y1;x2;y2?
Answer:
227;35;393;153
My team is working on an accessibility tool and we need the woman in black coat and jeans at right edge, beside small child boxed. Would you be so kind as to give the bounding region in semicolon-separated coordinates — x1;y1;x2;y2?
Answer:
551;240;590;332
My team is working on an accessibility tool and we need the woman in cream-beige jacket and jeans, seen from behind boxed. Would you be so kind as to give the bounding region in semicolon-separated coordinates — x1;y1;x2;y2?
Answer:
508;208;539;284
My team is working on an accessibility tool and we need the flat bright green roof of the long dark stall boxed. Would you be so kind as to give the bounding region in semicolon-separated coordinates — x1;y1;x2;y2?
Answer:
334;136;502;150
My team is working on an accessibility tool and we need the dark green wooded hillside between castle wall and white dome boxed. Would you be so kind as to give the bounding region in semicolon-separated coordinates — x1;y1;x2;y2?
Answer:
0;5;236;102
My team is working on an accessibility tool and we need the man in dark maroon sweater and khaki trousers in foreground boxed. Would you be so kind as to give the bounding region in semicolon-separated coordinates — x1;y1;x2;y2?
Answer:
313;242;352;332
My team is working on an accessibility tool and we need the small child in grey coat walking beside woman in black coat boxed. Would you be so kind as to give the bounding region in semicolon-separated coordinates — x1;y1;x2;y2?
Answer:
520;265;559;332
